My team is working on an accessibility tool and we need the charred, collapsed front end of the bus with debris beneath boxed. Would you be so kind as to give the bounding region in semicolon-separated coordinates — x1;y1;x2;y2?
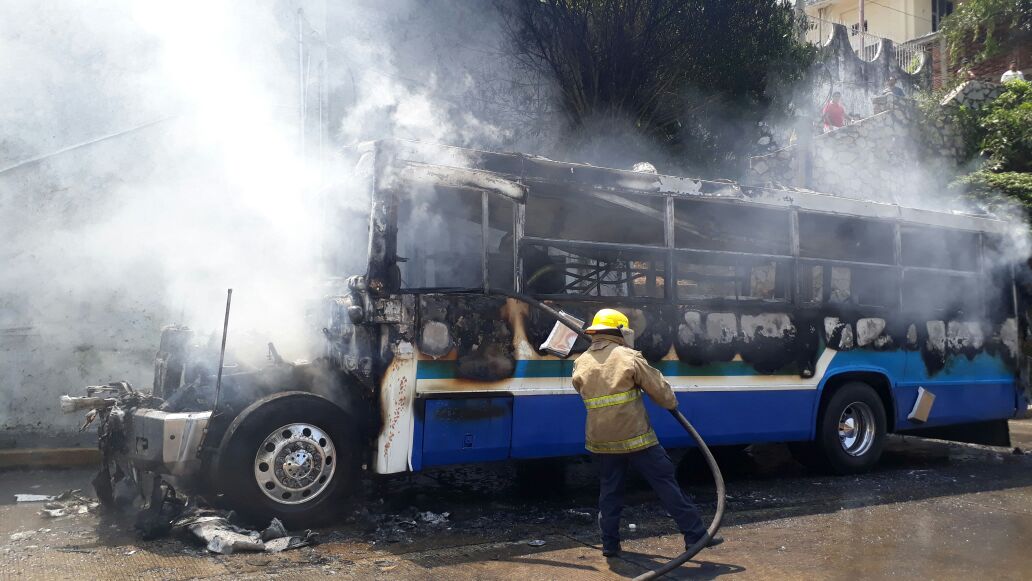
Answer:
61;325;355;554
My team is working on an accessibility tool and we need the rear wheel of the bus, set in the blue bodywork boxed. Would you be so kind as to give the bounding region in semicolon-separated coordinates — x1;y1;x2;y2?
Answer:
816;382;886;475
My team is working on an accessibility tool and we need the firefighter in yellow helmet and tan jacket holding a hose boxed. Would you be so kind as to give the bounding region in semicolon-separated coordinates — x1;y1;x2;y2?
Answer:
573;309;723;557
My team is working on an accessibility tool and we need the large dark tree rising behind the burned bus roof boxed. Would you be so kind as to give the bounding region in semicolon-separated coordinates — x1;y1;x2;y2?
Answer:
498;0;815;175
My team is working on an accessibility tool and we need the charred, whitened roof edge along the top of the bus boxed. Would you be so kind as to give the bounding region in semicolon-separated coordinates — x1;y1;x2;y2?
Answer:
355;139;1012;233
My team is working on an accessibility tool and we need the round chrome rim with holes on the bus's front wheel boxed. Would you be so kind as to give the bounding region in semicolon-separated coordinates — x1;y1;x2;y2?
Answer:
254;423;336;505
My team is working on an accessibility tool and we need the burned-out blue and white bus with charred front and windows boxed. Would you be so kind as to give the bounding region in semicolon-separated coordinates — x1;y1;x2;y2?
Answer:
65;140;1028;526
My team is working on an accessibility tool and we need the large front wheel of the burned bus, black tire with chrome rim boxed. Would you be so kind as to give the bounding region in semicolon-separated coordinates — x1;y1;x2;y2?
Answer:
212;391;357;529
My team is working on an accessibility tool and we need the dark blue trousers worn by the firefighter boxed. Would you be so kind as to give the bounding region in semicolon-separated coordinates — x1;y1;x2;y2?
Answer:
594;444;706;549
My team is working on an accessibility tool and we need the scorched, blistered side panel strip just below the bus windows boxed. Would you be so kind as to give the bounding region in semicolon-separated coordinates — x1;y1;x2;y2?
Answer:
419;293;1017;381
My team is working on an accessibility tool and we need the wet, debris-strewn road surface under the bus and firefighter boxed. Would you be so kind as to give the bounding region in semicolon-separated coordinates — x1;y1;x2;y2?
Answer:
0;421;1032;581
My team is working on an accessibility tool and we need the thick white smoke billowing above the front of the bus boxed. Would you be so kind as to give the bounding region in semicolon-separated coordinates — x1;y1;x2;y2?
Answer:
0;0;540;446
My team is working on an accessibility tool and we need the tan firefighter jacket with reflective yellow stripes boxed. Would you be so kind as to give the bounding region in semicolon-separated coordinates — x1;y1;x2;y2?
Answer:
573;335;677;454
